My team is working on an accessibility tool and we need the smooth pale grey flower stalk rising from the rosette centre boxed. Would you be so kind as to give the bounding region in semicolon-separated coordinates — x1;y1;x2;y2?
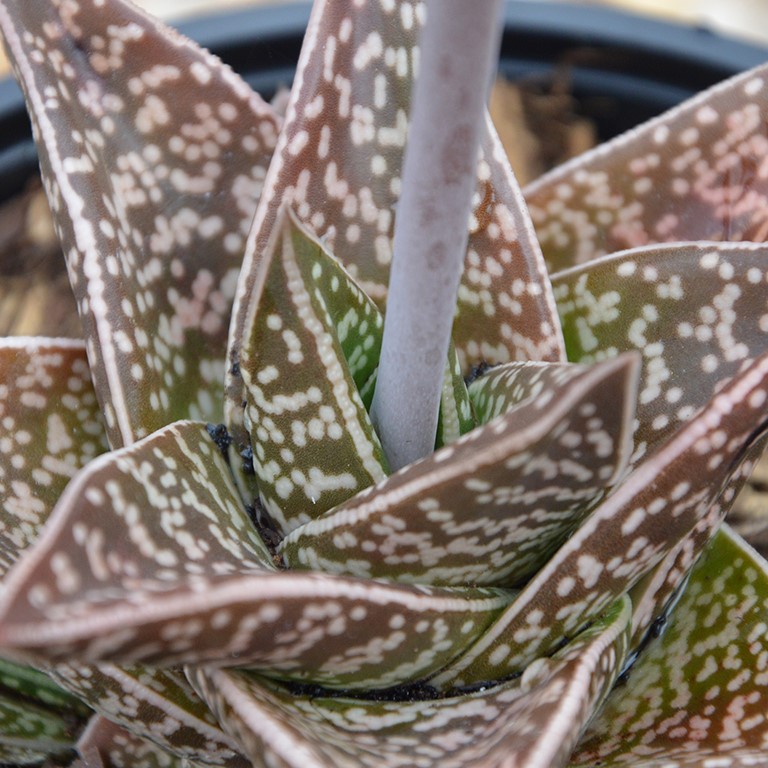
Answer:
371;0;502;471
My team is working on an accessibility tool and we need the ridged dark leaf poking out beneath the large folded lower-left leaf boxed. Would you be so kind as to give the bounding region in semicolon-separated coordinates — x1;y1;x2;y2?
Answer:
50;663;248;768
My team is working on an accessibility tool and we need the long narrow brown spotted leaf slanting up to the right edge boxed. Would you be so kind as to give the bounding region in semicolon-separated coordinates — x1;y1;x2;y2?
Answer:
434;355;768;687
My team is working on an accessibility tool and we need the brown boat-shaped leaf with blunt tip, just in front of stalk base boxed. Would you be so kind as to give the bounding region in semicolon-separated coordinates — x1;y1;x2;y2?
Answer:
278;355;638;586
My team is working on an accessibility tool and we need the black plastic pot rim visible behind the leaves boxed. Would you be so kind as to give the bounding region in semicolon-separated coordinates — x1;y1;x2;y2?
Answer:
0;0;768;200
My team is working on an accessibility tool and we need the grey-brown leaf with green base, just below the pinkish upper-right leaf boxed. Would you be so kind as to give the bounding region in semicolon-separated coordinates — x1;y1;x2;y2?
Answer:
552;243;768;464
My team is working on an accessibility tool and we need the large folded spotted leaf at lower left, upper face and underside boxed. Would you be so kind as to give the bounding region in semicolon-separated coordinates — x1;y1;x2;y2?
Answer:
0;422;513;688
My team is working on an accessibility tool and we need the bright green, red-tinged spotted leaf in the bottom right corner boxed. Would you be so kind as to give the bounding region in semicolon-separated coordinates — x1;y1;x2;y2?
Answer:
572;526;768;768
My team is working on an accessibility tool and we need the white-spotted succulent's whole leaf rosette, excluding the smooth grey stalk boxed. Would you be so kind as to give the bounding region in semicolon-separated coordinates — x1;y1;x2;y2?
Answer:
0;0;768;768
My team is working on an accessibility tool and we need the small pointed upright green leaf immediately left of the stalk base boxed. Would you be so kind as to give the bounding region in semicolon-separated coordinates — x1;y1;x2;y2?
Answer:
240;212;387;533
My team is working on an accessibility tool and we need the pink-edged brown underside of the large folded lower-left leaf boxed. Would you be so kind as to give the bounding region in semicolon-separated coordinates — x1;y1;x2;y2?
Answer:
0;572;512;692
